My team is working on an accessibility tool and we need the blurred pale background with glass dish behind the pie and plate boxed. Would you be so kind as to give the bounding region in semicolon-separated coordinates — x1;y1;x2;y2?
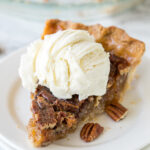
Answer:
0;0;150;150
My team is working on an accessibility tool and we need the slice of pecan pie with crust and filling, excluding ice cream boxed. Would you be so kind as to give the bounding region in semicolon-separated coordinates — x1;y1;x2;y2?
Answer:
28;19;145;147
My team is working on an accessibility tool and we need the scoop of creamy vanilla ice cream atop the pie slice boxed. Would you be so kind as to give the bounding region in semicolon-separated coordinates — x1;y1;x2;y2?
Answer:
19;29;110;100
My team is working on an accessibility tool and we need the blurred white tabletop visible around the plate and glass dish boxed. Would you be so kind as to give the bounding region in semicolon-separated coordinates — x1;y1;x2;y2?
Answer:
0;0;150;150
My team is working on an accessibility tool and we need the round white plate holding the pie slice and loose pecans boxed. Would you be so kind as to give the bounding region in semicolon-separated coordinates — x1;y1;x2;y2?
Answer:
0;48;150;150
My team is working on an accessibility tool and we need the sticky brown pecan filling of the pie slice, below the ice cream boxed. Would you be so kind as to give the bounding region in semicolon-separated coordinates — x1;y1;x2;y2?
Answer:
28;54;130;146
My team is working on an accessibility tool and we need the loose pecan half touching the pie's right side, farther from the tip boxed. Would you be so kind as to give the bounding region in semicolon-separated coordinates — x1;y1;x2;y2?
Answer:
105;102;128;121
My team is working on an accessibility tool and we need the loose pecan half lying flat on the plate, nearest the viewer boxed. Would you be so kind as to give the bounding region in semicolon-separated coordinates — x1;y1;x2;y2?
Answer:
80;123;104;142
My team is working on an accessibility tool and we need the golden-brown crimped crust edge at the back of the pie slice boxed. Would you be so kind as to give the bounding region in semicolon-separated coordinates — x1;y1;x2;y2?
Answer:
42;19;145;66
